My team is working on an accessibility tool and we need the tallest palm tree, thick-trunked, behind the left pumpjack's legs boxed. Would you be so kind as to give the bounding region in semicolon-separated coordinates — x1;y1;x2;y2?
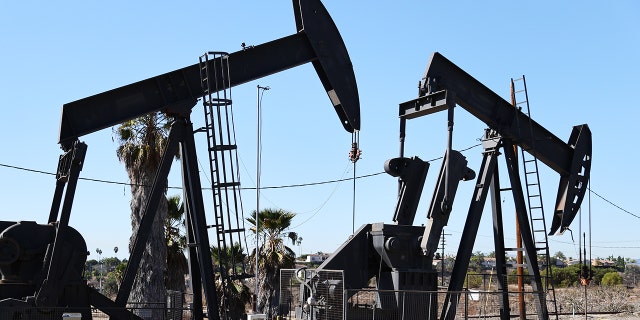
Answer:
116;113;170;319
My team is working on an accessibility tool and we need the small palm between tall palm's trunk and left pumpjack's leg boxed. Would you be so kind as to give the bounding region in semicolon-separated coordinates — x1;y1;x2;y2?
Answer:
164;195;189;292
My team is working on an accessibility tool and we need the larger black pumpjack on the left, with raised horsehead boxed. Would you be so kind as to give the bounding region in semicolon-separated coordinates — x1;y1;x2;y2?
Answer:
0;0;360;319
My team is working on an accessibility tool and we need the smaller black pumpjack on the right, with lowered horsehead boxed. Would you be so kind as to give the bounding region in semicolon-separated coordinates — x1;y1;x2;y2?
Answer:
296;52;592;320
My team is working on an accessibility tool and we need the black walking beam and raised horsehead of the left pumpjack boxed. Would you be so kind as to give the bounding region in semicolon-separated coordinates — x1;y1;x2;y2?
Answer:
59;0;360;145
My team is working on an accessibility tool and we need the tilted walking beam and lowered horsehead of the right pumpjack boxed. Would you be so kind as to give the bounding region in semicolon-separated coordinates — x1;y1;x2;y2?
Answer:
399;52;591;234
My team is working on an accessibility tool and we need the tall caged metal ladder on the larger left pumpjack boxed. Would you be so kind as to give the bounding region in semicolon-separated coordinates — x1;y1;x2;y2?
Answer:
196;52;250;299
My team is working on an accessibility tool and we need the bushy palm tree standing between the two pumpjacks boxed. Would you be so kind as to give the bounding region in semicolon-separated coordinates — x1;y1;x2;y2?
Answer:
247;208;298;313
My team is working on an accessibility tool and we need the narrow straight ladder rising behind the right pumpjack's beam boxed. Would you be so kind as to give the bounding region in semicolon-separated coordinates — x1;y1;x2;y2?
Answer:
511;75;558;319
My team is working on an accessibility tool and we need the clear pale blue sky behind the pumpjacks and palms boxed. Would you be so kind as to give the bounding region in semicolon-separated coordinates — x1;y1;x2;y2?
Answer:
0;0;640;259
